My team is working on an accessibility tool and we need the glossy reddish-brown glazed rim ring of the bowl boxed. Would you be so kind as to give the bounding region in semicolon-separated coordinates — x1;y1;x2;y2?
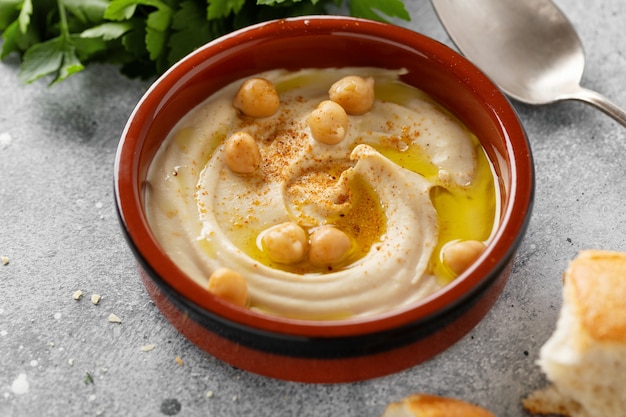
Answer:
114;16;534;338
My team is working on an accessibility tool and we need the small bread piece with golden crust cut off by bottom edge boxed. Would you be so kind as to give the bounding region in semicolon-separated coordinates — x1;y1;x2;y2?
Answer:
382;394;495;417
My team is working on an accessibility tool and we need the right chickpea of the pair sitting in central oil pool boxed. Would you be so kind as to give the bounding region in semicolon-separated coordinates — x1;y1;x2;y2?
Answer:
309;226;352;265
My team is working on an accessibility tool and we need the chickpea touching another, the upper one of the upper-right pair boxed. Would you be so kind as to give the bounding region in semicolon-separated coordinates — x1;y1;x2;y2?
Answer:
328;75;374;115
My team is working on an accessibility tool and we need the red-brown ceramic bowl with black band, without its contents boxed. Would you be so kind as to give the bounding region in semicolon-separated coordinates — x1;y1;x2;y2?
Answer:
115;17;534;382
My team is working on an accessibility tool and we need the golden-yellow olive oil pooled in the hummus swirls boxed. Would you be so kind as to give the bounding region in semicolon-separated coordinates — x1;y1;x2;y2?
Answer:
193;74;498;285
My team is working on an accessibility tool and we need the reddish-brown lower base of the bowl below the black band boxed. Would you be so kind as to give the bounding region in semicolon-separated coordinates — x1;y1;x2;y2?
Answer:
139;261;512;383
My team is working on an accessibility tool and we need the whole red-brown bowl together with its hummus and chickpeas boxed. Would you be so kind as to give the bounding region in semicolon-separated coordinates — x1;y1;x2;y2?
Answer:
115;16;534;383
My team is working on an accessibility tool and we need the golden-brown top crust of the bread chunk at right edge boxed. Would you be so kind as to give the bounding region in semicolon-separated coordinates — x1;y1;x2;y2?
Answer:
564;250;626;343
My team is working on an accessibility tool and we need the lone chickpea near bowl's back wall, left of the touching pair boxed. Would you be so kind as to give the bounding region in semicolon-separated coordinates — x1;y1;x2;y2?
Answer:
233;78;280;118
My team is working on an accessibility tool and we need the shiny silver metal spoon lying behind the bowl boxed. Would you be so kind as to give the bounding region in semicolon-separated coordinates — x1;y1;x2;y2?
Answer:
431;0;626;126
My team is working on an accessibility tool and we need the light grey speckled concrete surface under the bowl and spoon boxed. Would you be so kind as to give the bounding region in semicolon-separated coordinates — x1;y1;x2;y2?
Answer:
0;0;626;417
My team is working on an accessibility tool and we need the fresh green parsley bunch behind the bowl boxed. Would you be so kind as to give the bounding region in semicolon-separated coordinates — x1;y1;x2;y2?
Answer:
0;0;410;84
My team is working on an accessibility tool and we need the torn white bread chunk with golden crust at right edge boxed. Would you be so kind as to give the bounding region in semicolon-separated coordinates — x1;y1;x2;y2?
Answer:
523;250;626;417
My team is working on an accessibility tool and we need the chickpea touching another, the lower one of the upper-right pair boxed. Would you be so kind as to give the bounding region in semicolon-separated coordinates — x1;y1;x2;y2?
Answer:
307;100;348;145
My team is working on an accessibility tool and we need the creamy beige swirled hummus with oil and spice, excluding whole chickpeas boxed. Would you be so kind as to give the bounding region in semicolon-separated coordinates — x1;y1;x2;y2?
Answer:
146;68;498;319
